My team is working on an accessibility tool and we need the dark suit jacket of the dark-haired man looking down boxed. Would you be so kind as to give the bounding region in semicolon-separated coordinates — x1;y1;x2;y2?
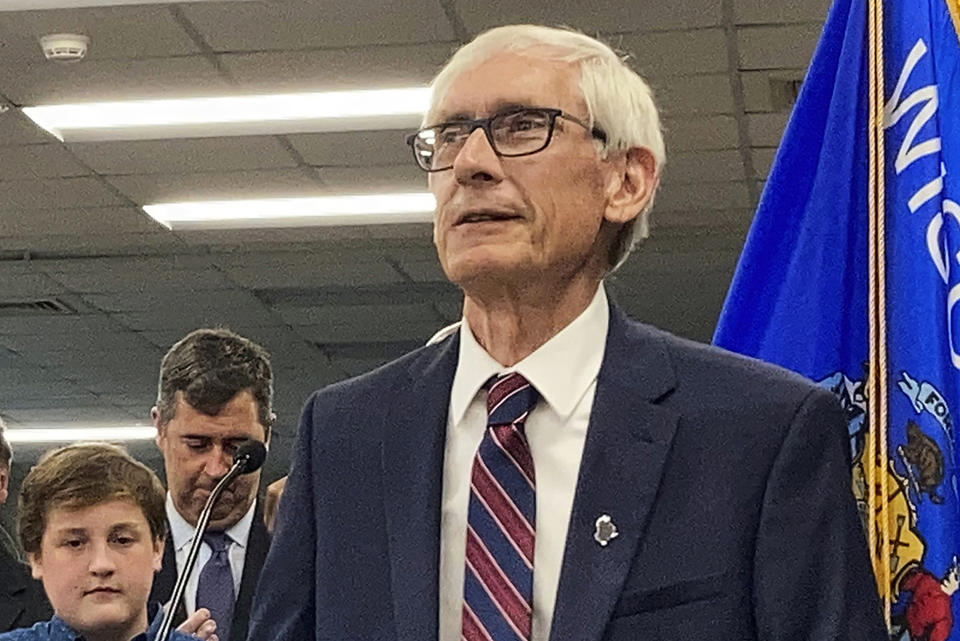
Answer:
150;501;270;641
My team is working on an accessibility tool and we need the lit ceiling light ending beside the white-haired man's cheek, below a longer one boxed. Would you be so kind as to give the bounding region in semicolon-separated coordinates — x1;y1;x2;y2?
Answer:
143;192;436;229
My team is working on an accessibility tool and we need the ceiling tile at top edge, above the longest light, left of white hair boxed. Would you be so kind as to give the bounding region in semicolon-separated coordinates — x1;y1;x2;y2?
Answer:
182;0;453;51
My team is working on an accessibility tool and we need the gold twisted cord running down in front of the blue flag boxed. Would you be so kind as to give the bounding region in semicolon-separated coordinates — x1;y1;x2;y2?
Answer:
867;0;892;629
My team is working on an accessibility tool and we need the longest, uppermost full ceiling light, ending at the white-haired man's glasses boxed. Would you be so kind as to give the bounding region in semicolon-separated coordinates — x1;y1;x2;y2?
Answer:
23;87;430;142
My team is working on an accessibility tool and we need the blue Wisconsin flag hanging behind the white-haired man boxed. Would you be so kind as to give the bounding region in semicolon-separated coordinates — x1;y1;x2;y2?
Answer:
714;0;960;641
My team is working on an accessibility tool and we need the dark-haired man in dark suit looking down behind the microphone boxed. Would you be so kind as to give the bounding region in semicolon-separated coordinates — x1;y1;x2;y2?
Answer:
150;329;276;641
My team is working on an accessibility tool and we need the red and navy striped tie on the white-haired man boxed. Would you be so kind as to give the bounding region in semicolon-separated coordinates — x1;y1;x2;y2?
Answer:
461;373;539;641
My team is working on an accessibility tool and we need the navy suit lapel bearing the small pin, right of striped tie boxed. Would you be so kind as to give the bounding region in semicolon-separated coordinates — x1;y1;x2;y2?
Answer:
550;307;678;641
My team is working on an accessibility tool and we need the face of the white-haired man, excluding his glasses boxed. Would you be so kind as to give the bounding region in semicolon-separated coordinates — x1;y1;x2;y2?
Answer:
429;54;624;286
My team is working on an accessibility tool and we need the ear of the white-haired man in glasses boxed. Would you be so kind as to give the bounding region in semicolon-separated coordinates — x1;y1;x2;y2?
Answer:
604;147;660;225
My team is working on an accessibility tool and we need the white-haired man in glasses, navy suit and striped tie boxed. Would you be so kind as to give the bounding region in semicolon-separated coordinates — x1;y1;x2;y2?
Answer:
250;26;885;641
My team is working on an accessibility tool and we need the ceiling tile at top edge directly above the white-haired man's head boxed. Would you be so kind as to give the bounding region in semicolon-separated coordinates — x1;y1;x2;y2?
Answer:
456;0;723;34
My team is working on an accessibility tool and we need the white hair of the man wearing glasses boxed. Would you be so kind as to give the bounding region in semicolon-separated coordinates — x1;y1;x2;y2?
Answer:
423;25;666;269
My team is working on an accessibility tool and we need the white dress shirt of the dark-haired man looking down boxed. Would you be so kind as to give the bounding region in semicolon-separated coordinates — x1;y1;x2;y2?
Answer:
167;492;257;616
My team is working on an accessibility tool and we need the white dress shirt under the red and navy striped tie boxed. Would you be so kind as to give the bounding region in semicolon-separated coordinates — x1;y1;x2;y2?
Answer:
440;285;610;641
